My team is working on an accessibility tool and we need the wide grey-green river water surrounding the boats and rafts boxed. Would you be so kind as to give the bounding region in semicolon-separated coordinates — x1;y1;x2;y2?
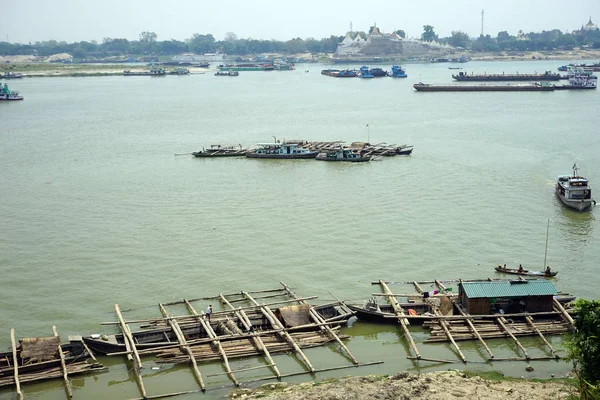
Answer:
0;61;600;400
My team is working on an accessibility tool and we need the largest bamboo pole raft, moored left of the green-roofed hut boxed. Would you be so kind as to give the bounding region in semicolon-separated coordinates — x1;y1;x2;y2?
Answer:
90;282;382;399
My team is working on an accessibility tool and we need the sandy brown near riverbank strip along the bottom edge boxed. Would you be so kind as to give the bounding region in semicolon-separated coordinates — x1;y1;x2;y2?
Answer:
229;371;578;400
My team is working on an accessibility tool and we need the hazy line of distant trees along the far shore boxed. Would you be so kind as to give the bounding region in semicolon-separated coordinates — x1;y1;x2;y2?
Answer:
0;25;600;60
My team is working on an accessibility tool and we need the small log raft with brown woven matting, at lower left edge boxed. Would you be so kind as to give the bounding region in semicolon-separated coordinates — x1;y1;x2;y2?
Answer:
0;336;106;387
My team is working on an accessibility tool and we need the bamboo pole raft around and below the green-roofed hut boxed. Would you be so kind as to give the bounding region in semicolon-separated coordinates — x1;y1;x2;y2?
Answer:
353;278;574;363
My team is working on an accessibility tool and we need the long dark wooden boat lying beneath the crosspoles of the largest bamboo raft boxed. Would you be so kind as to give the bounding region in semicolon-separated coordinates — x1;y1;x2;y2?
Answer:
83;304;353;354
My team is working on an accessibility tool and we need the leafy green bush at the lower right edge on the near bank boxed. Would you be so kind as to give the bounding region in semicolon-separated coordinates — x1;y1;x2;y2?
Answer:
565;299;600;400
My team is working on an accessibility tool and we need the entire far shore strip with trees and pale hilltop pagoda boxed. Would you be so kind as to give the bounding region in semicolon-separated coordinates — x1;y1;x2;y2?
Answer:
0;17;600;63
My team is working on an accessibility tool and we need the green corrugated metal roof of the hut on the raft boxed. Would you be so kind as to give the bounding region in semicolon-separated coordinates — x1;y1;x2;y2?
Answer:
462;280;558;299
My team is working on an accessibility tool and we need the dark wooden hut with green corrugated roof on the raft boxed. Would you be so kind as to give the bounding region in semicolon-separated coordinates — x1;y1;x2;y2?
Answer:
458;280;558;315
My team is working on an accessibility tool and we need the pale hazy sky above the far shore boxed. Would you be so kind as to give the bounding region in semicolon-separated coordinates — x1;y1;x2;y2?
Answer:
0;0;600;43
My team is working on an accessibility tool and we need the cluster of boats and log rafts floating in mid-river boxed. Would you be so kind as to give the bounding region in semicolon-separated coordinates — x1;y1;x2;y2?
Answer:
191;140;413;162
